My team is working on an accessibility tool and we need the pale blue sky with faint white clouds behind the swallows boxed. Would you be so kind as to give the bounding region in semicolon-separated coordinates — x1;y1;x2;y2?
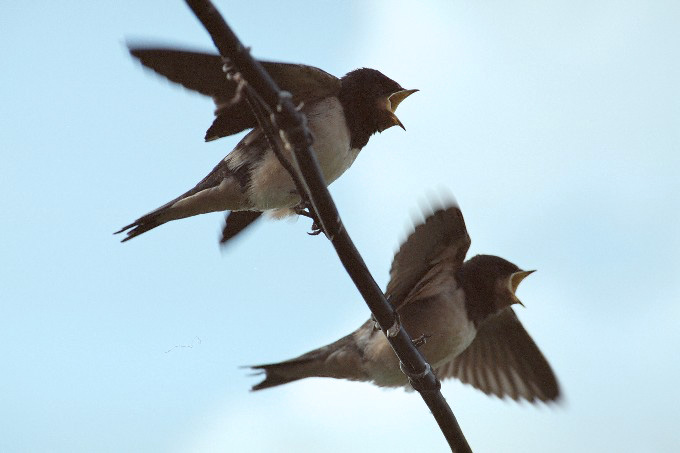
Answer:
0;0;680;452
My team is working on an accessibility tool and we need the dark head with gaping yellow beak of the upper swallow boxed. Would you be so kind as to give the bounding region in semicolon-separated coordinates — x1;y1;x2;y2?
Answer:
338;68;418;149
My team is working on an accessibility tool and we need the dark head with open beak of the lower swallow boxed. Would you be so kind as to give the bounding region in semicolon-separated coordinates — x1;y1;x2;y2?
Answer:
457;255;535;323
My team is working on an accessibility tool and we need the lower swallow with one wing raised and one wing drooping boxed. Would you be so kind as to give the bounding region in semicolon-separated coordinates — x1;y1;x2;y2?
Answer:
249;203;560;403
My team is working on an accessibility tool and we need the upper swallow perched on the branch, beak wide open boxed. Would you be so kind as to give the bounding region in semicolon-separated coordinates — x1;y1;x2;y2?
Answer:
114;45;418;243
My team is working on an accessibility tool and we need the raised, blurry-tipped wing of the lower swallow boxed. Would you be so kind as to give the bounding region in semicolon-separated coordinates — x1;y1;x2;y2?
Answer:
386;206;470;308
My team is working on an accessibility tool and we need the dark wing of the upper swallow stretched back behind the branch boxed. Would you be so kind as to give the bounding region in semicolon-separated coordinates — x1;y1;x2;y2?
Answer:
130;46;340;141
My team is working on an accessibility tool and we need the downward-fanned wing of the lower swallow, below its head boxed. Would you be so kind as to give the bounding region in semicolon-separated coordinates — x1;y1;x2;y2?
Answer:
436;308;559;402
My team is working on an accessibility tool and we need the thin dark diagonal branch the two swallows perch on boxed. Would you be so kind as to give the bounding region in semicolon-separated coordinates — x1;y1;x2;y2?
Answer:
186;0;472;452
